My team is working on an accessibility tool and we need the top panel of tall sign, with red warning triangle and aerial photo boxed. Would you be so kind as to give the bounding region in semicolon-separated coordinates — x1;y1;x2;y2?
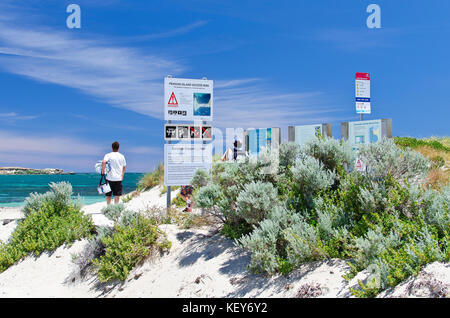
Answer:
164;77;213;121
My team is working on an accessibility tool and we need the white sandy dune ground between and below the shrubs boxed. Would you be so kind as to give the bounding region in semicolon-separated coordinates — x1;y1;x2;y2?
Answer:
0;187;450;298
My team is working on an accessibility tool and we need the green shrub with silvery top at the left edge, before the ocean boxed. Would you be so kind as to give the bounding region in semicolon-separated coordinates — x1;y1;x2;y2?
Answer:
0;183;95;272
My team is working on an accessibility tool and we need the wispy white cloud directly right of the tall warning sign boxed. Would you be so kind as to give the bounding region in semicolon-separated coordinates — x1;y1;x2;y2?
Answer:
214;80;340;129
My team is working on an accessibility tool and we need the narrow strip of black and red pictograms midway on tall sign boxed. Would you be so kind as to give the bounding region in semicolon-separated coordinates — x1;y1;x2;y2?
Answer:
164;124;212;141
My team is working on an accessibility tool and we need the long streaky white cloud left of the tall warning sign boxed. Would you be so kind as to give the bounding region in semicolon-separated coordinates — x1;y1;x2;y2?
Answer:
0;4;185;117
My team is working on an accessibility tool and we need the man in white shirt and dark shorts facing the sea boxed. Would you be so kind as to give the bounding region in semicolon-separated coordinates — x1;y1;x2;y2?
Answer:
102;141;127;205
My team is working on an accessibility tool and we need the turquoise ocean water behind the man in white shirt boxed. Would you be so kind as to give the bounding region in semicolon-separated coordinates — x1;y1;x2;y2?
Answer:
0;173;143;207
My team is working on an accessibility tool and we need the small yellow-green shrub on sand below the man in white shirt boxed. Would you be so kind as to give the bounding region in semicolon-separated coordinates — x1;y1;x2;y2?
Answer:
92;215;171;282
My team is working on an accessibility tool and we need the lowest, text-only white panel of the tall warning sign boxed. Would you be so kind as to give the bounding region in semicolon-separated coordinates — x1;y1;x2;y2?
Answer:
164;144;212;186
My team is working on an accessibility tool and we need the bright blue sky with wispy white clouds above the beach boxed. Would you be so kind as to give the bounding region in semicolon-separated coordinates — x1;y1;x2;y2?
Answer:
0;0;450;172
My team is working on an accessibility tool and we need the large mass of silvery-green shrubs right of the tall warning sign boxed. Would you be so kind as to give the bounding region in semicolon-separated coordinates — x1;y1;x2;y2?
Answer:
195;137;450;297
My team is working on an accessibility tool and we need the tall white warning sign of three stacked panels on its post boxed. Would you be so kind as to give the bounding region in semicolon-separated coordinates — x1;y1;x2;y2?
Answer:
164;76;213;210
